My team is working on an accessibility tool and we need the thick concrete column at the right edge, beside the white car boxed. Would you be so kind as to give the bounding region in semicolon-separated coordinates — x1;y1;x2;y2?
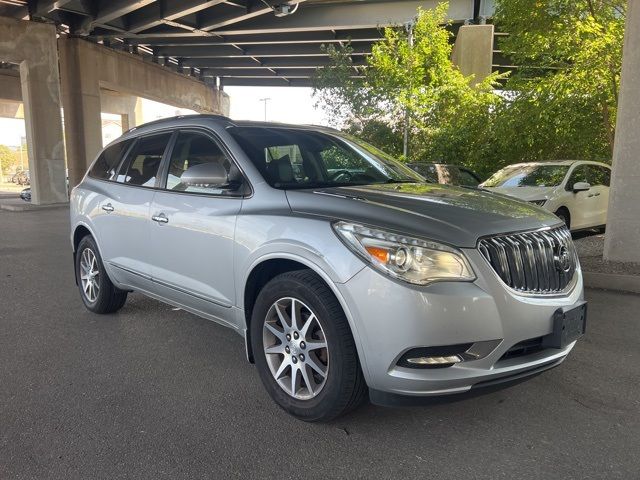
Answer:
604;1;640;263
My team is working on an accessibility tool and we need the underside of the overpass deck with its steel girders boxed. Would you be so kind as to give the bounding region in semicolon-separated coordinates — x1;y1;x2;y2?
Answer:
0;0;493;86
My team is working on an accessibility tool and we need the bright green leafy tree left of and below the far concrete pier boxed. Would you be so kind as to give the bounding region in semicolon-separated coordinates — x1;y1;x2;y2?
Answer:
314;3;501;176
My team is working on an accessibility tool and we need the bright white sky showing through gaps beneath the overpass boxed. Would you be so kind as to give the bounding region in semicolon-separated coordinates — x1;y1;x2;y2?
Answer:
0;87;329;147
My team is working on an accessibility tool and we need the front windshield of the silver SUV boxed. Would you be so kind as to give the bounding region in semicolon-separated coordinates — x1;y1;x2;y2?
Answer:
228;127;424;189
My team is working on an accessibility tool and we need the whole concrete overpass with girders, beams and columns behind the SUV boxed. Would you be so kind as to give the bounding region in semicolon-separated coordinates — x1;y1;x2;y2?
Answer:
0;0;493;204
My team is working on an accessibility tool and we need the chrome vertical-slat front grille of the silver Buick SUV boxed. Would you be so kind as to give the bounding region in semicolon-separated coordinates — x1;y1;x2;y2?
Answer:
478;227;578;294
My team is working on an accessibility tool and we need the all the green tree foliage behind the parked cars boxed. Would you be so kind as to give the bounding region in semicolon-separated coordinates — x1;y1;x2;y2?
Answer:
314;0;625;176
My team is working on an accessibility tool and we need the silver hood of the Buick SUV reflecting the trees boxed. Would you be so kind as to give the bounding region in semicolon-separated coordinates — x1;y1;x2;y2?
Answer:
286;183;560;248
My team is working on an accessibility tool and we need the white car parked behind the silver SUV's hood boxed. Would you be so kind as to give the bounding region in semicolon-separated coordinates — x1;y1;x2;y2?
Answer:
480;160;611;230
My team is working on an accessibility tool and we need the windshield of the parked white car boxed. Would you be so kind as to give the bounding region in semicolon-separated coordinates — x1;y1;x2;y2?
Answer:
482;165;569;187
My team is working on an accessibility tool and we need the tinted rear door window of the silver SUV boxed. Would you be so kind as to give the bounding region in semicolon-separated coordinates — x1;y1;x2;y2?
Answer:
118;133;171;187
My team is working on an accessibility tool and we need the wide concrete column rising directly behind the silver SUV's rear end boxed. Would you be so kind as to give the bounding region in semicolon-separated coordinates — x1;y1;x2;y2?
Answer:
58;37;102;187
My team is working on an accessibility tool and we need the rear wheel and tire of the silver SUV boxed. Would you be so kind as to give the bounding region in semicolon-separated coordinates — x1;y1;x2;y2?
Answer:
75;235;127;314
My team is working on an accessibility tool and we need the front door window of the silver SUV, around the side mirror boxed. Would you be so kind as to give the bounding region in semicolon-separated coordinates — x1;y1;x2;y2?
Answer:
166;132;237;195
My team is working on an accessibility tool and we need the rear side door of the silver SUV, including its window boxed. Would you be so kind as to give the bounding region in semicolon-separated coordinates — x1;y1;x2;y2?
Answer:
94;133;172;289
